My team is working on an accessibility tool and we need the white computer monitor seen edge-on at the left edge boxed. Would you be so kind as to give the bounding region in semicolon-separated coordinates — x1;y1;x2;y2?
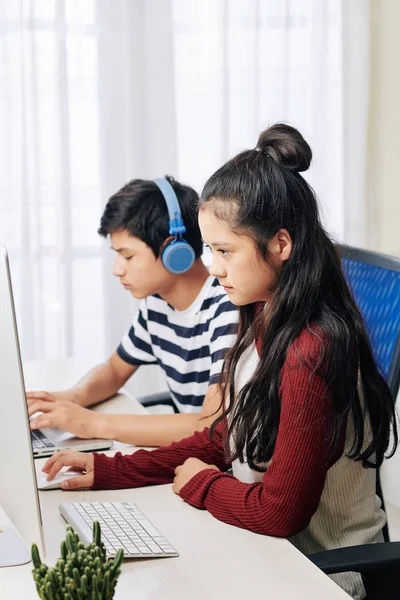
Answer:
0;244;45;554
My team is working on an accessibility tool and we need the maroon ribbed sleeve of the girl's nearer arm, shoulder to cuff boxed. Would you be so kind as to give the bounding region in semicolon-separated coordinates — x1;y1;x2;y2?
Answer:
180;332;345;537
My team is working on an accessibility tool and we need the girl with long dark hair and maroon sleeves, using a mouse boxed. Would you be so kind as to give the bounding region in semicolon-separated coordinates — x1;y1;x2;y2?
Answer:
44;124;397;600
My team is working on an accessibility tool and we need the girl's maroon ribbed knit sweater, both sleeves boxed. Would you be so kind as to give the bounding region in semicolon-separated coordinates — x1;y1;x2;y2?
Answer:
92;331;345;537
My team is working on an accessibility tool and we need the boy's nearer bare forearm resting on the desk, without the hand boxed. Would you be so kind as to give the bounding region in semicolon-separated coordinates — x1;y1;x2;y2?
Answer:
96;414;210;447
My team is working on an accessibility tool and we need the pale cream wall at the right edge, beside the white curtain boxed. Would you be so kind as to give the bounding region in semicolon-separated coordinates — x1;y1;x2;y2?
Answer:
368;0;400;509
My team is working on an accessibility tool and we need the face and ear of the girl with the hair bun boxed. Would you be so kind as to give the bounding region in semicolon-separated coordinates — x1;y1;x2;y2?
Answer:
199;205;292;306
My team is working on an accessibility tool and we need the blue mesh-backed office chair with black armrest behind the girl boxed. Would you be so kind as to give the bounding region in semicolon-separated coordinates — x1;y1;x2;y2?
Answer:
308;246;400;600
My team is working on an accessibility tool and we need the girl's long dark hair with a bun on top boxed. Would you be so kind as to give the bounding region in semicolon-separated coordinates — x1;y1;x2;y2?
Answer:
200;124;398;470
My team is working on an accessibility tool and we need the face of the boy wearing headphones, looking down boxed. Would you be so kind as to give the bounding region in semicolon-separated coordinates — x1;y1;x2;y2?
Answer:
110;231;171;300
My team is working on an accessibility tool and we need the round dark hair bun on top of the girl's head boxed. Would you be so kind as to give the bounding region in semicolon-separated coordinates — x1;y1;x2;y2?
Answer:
257;123;312;172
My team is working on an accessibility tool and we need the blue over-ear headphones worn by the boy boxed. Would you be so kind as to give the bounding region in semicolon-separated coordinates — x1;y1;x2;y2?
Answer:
153;179;195;275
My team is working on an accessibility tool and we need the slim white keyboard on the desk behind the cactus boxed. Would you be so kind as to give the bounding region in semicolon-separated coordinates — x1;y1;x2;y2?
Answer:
59;502;179;558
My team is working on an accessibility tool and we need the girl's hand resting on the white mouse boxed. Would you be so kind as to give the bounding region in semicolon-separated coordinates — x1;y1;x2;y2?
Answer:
42;450;94;490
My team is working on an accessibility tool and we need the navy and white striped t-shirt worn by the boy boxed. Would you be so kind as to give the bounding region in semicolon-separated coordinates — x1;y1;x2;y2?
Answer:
117;277;238;413
